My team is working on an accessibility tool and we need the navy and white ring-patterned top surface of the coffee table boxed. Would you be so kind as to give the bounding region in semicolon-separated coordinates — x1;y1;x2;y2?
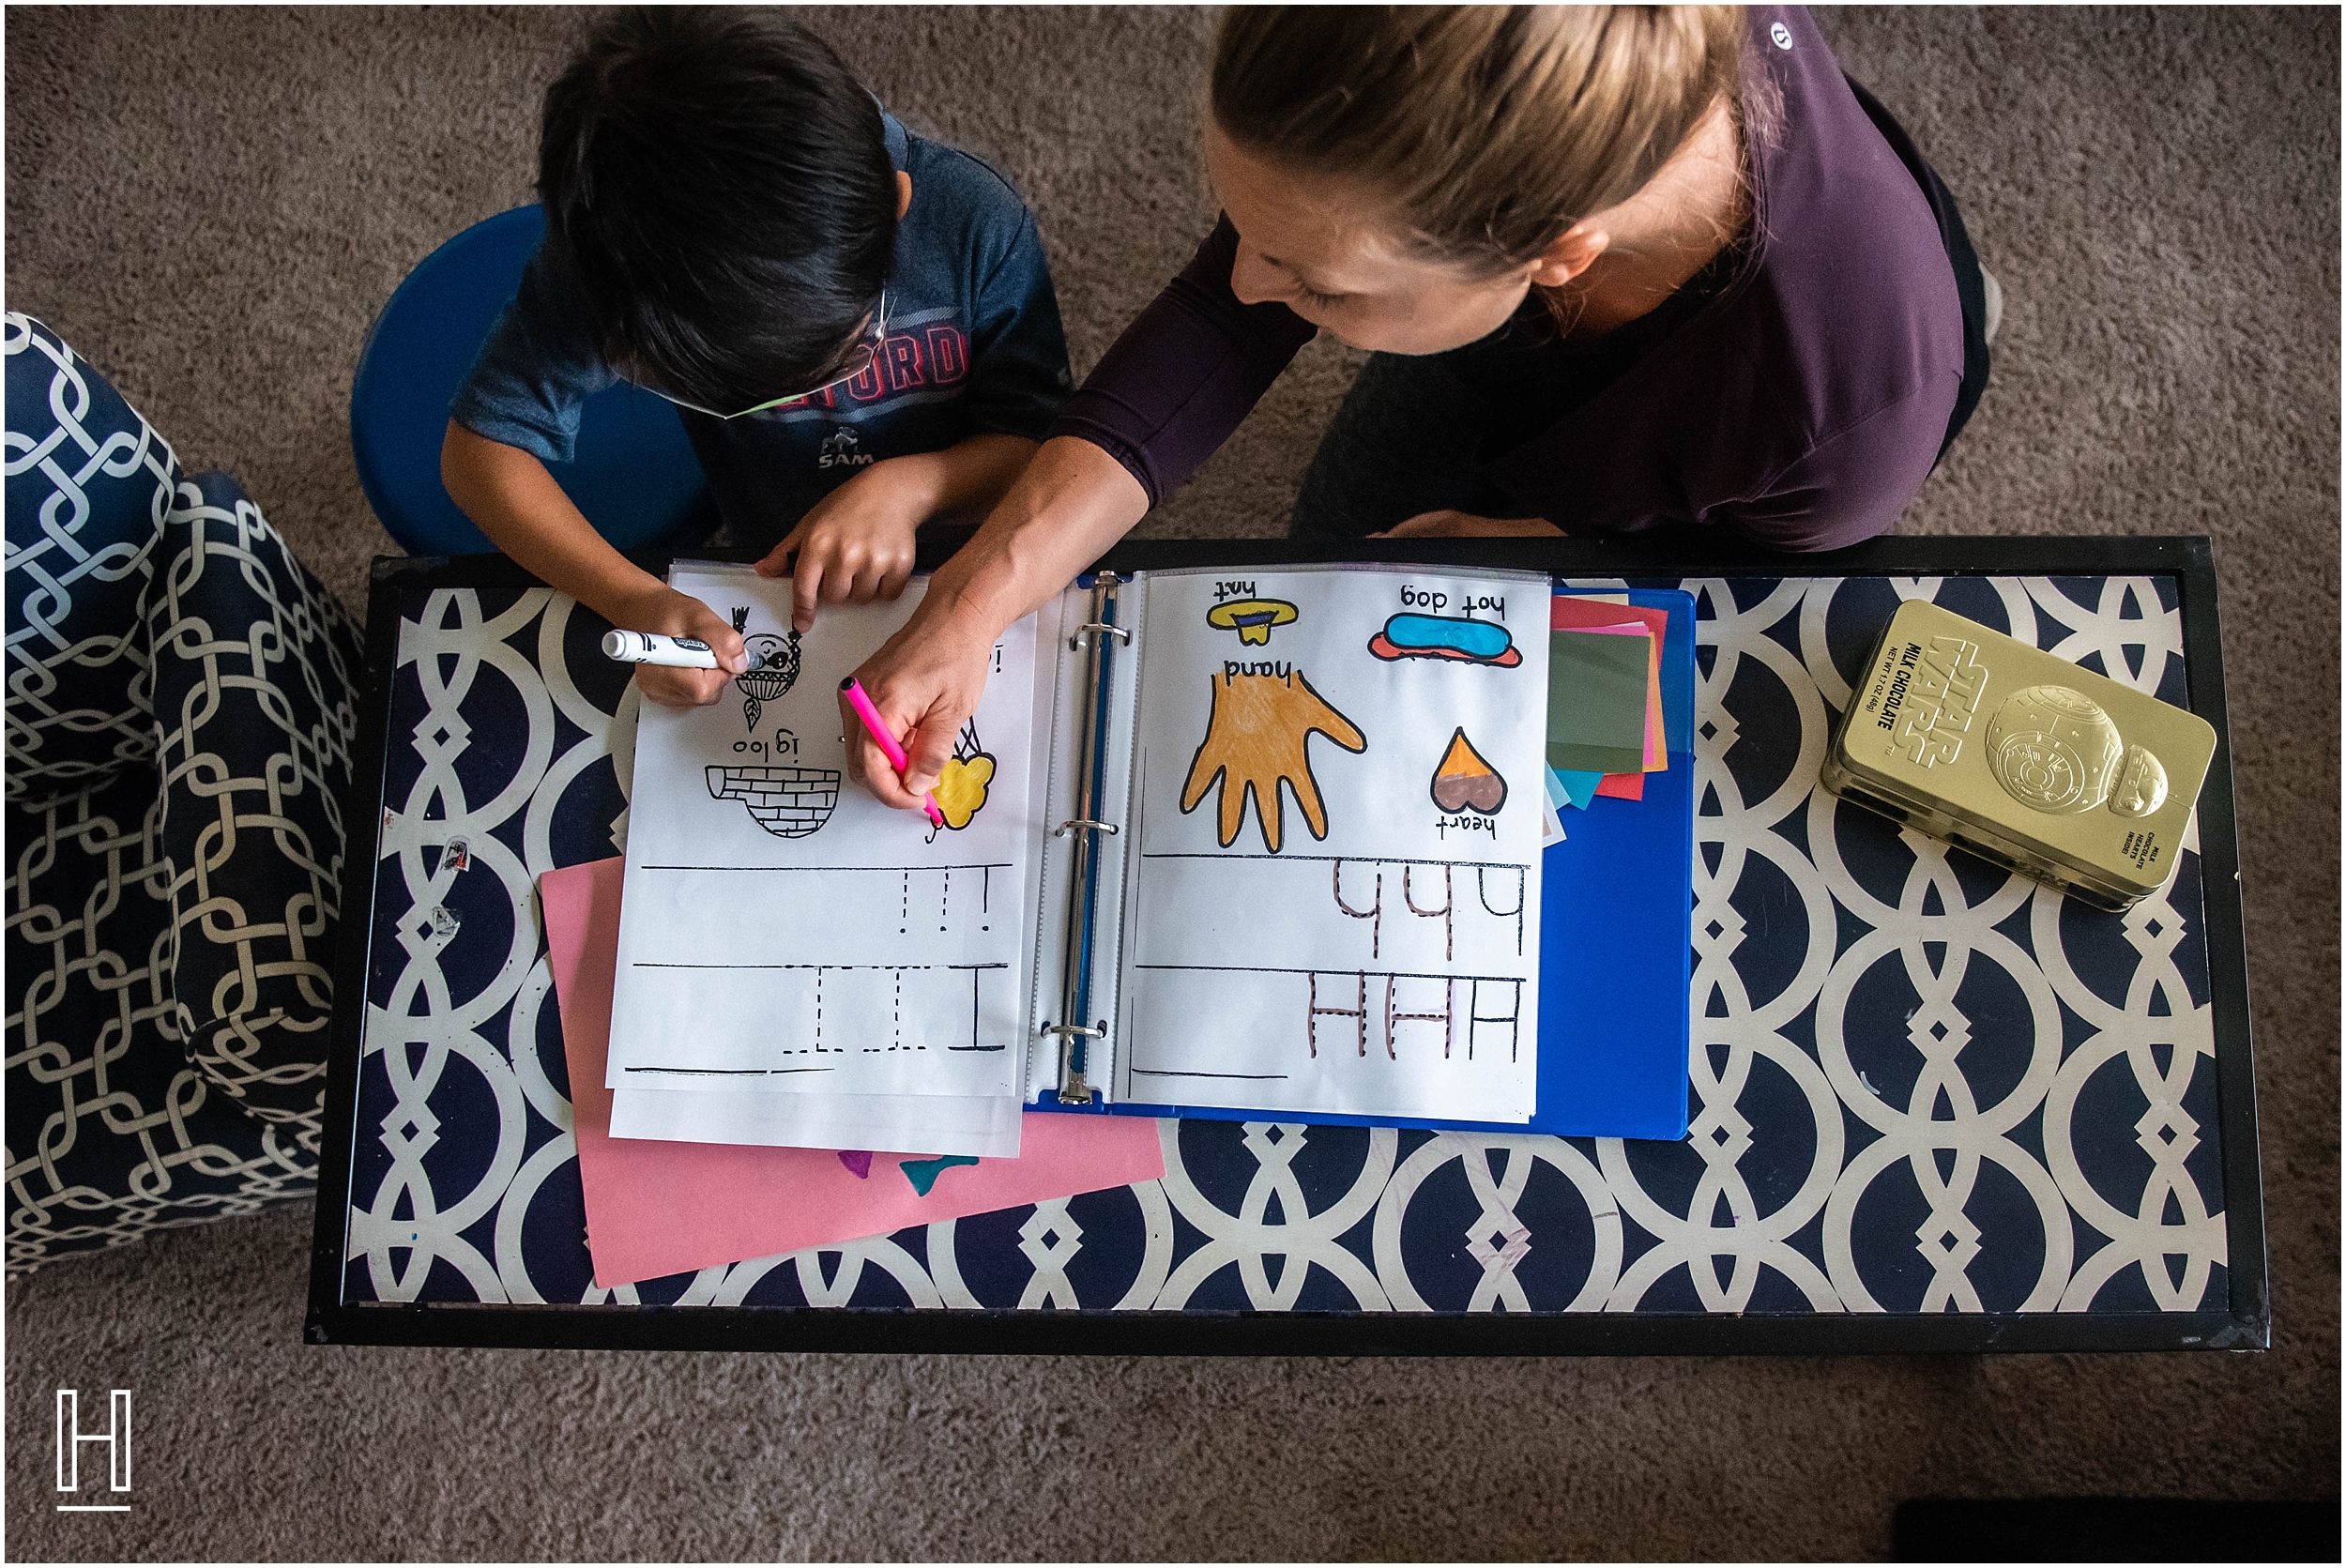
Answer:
345;577;2227;1315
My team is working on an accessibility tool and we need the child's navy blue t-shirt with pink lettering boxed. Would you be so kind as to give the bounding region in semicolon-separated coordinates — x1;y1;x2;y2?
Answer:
449;115;1074;547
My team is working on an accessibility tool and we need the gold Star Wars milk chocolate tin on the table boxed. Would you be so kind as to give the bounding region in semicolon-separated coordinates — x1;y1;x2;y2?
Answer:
1823;601;2215;911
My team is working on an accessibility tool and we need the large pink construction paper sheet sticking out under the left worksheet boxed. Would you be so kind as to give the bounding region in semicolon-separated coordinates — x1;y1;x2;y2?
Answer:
538;860;1166;1286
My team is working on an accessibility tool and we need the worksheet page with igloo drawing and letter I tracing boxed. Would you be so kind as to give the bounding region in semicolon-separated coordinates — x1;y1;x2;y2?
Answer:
605;566;1035;1103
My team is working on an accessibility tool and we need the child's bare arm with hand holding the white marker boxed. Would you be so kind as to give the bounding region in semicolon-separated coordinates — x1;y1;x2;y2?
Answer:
441;420;749;707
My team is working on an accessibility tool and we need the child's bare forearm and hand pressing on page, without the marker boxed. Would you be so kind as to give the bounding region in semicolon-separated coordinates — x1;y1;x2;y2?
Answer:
755;432;1035;632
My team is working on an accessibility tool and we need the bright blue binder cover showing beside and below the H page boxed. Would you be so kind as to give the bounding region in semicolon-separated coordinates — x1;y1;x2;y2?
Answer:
1030;589;1694;1141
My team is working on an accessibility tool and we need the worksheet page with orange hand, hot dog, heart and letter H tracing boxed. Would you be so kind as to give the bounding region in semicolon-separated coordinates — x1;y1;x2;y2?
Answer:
1117;568;1548;1122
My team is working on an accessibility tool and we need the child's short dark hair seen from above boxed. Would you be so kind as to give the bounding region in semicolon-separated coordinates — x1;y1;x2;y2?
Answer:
538;8;896;413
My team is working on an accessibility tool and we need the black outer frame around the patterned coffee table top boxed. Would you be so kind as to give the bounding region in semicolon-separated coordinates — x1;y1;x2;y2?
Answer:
305;533;2271;1354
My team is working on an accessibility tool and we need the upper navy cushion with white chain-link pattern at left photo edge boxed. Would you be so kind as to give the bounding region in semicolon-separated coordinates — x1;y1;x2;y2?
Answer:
0;312;178;805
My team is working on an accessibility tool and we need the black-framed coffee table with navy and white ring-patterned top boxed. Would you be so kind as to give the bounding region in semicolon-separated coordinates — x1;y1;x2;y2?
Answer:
308;538;2269;1354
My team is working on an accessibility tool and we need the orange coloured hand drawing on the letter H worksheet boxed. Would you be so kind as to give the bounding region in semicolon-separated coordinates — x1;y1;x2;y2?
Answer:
1181;666;1368;855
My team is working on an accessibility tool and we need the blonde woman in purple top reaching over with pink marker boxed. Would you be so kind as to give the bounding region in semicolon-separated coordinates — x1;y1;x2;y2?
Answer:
847;8;1988;808
